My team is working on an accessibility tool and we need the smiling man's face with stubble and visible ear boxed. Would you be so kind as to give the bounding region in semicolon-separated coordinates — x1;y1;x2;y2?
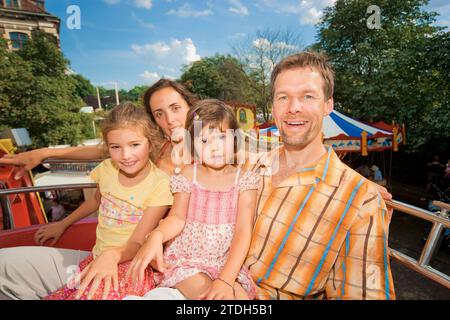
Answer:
272;67;333;150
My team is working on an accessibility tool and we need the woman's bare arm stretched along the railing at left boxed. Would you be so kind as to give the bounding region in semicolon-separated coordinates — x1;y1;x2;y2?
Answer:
0;145;106;180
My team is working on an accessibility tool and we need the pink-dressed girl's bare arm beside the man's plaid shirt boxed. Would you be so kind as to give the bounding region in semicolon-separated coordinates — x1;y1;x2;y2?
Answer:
199;190;257;300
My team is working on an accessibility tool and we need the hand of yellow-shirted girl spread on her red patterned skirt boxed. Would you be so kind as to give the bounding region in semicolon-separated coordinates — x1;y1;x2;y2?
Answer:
75;250;119;300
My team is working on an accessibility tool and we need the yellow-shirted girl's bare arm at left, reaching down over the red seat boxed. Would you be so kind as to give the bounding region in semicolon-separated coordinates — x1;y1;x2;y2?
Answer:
34;188;101;245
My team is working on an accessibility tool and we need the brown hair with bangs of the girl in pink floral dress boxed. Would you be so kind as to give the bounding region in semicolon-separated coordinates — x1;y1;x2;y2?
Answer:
185;99;240;159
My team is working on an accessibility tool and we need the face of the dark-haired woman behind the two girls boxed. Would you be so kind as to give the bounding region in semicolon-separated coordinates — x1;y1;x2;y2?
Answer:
150;87;189;137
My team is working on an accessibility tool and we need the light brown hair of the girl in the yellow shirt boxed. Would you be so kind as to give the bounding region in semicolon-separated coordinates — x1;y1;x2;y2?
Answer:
101;102;163;161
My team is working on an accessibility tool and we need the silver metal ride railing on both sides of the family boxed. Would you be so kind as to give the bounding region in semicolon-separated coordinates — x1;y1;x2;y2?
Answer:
0;183;450;289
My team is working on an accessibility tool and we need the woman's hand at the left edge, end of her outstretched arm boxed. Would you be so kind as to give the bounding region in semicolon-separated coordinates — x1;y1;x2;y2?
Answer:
0;149;45;180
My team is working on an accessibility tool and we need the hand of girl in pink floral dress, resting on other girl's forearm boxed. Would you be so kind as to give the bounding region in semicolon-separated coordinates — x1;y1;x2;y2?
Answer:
126;230;164;285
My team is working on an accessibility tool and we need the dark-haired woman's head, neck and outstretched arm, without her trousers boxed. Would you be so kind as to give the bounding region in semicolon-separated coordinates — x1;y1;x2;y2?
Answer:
0;79;197;179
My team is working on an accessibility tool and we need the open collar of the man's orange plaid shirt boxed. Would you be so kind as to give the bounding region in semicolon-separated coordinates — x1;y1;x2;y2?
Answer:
260;145;344;187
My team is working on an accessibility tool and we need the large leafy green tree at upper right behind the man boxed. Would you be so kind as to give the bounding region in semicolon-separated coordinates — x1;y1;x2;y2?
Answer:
313;0;450;151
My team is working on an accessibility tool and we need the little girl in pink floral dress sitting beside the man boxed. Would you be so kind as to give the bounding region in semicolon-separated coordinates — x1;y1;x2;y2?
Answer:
128;100;259;299
